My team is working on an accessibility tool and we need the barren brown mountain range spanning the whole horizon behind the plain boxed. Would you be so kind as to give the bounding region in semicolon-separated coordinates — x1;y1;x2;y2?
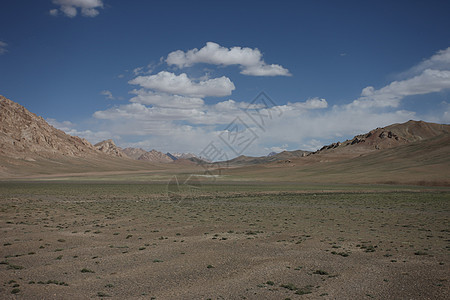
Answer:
0;96;450;182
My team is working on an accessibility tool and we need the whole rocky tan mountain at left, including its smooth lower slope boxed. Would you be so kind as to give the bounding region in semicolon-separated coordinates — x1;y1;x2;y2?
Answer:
0;96;165;178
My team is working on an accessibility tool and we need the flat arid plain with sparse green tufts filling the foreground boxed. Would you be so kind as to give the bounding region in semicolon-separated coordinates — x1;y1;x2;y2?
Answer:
0;182;450;299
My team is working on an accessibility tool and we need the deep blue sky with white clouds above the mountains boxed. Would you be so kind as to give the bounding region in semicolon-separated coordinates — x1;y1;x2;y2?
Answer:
0;0;450;160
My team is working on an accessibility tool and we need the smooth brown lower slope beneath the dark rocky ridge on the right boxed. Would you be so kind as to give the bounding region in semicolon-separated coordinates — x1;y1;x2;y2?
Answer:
224;133;450;186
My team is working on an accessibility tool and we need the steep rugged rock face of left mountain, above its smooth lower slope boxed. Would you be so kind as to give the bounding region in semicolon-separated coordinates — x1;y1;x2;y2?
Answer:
0;96;98;160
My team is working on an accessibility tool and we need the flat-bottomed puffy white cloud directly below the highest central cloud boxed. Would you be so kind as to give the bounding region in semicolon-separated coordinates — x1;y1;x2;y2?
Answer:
129;71;235;97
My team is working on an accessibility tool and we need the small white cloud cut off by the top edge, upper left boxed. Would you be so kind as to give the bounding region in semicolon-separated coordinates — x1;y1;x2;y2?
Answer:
49;0;103;18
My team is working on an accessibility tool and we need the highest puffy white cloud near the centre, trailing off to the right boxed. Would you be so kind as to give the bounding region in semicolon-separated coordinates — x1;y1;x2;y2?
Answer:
166;42;291;76
